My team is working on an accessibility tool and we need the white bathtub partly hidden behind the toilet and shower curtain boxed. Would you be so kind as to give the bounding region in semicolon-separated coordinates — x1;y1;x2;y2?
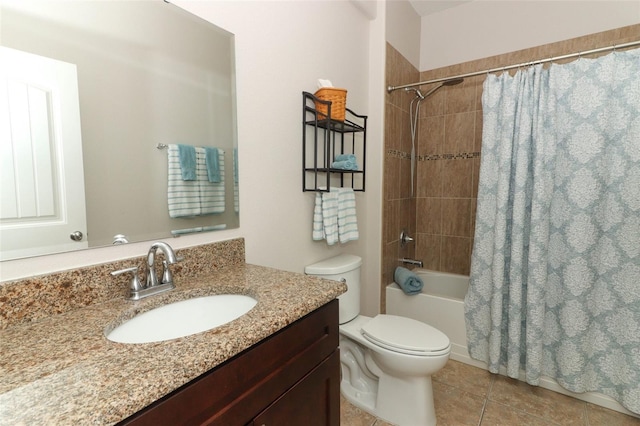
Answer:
387;269;476;366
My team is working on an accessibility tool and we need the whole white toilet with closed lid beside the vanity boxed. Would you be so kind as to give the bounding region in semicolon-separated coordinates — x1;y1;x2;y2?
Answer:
305;254;451;426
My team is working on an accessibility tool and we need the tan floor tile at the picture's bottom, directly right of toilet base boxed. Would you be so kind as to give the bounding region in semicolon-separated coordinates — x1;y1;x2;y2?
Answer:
433;381;484;426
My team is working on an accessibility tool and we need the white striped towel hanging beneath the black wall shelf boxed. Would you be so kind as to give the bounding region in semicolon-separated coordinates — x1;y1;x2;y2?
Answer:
312;188;359;245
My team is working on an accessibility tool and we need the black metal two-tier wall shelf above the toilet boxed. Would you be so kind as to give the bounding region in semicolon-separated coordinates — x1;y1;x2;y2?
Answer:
302;92;367;192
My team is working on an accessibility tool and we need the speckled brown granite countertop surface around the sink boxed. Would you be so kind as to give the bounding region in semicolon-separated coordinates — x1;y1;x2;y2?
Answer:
0;264;346;425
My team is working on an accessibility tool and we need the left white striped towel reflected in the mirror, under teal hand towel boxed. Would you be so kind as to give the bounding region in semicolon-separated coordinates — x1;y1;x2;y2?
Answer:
167;144;201;218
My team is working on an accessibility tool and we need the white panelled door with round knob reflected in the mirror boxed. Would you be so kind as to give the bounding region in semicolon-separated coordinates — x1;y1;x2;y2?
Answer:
0;47;87;260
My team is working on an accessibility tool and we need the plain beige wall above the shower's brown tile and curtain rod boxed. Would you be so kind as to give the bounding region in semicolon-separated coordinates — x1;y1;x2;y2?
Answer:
420;0;640;71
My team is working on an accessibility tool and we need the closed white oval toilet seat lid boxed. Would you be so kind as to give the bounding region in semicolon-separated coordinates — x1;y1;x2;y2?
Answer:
360;314;451;356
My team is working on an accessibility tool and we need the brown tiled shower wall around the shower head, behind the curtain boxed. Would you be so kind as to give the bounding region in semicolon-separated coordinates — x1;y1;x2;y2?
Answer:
380;24;640;312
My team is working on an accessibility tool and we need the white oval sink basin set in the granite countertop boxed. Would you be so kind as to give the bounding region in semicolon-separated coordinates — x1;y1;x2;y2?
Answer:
107;294;257;343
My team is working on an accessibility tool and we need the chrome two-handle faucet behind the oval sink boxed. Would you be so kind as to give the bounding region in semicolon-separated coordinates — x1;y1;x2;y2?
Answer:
111;241;182;300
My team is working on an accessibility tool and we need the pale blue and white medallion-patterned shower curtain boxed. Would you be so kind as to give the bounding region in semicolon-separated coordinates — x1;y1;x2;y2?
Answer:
465;49;640;413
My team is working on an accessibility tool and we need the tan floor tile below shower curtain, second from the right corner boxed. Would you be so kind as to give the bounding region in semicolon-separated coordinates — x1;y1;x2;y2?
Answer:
489;376;586;426
